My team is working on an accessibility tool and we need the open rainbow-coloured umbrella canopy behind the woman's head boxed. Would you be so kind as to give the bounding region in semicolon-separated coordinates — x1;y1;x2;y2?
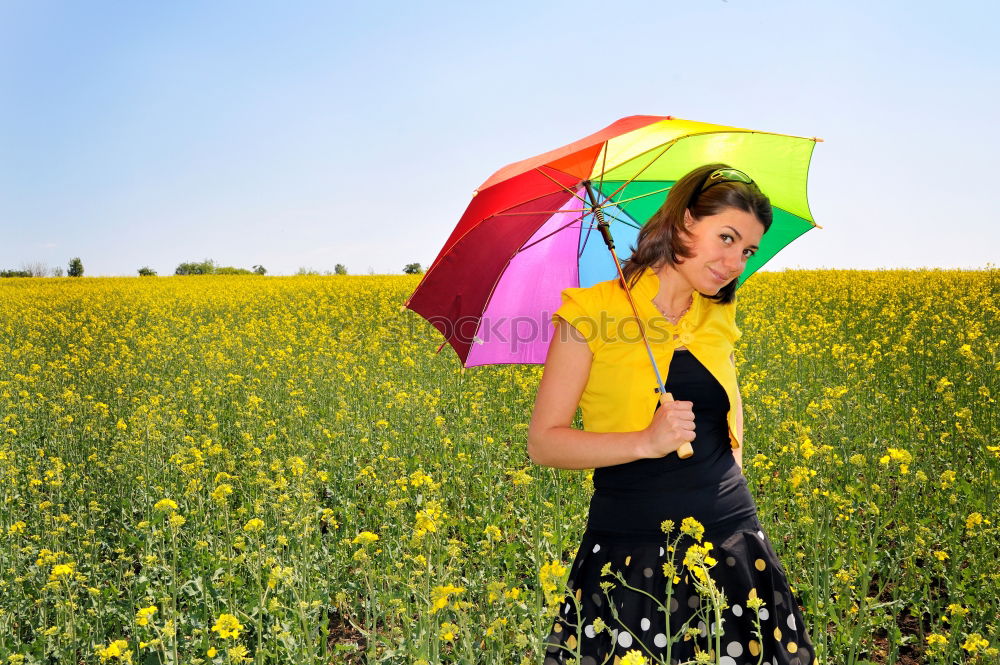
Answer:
406;116;820;367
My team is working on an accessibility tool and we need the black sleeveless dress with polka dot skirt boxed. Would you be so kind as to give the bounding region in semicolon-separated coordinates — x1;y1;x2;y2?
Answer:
543;350;816;665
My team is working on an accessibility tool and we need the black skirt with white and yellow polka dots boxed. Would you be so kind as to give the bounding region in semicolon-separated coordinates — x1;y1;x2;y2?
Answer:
543;517;817;665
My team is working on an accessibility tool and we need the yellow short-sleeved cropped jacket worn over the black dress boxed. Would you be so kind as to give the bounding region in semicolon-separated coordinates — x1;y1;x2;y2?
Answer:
553;268;742;448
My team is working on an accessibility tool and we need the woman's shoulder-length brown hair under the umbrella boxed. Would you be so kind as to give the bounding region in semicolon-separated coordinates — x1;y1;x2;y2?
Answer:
622;164;773;304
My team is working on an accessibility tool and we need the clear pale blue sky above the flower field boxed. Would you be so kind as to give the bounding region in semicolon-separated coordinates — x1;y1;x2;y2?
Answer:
0;0;1000;275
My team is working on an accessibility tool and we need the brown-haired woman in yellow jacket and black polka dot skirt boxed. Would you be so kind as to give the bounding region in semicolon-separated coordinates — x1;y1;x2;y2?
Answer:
528;164;816;665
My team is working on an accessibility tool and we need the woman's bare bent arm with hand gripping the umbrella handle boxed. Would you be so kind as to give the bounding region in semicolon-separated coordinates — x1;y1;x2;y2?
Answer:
528;321;694;469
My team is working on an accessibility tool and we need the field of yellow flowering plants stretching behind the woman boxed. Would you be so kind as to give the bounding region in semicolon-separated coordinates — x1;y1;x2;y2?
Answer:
0;269;1000;665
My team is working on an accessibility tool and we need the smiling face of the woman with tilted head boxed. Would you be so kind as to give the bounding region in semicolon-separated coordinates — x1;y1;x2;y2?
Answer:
674;208;764;296
